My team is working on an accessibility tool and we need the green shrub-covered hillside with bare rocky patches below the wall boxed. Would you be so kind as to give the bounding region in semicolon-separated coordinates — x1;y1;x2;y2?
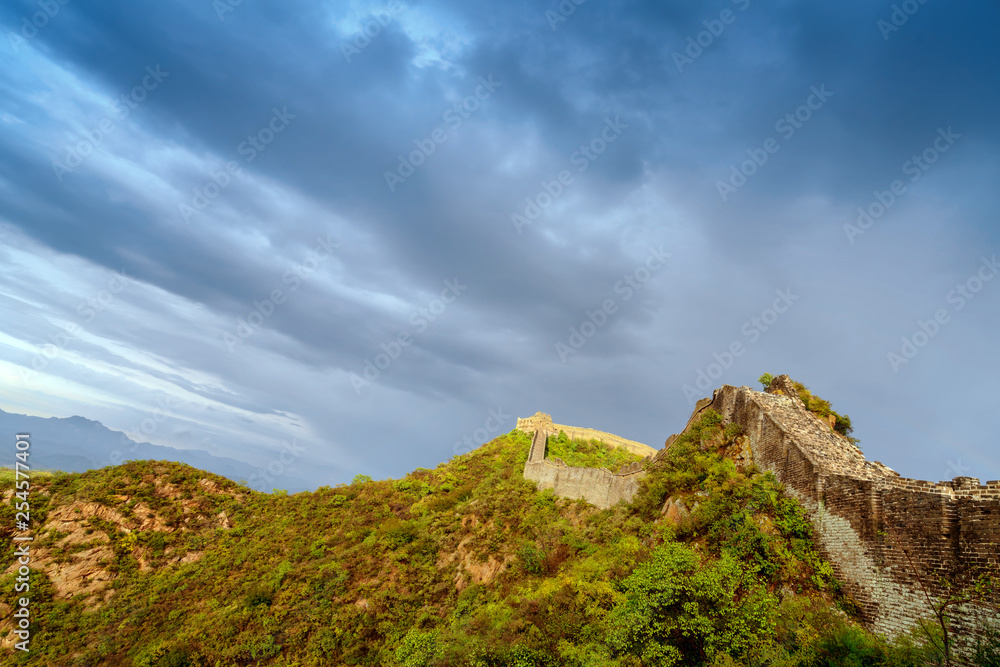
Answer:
0;410;968;667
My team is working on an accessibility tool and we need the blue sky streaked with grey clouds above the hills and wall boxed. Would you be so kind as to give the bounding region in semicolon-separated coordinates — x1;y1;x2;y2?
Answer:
0;0;1000;488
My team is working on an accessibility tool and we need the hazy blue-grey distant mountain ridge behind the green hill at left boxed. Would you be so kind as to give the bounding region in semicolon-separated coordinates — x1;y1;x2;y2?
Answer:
0;410;262;490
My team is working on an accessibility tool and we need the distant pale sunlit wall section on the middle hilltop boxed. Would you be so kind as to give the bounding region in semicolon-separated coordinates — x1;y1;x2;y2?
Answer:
517;412;656;509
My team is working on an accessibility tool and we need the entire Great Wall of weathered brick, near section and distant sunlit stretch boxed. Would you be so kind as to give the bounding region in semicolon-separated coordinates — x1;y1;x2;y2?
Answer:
518;375;1000;643
